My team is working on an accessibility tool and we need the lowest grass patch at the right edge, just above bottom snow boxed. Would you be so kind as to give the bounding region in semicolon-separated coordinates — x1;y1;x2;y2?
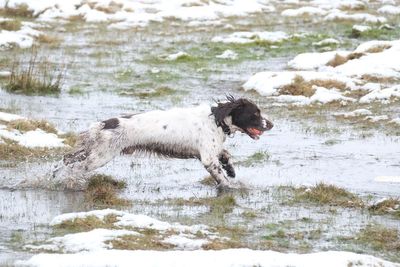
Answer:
356;225;400;253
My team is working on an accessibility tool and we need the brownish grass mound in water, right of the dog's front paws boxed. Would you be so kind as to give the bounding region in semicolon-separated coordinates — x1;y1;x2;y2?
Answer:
294;183;364;208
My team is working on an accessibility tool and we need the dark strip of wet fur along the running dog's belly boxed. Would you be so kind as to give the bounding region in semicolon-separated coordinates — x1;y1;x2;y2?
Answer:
121;143;200;159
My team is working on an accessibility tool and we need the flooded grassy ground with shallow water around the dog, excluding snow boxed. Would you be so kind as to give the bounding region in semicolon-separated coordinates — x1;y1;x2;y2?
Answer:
0;6;400;264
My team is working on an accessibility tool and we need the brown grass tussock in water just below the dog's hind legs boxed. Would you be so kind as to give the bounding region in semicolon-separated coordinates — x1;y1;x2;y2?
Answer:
85;174;131;207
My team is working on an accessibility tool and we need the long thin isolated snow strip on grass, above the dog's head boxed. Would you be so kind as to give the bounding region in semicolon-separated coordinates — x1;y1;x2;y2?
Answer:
211;31;290;44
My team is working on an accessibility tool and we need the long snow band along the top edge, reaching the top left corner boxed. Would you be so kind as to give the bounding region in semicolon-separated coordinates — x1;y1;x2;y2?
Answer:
0;0;275;26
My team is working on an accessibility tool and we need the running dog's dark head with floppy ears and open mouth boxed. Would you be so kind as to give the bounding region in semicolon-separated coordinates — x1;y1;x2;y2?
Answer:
211;96;274;139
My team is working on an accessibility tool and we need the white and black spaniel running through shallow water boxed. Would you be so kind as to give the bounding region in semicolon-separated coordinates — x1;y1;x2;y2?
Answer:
53;96;273;191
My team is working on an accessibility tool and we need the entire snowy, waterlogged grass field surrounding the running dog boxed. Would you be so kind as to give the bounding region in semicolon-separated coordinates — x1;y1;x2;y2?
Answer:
0;0;400;266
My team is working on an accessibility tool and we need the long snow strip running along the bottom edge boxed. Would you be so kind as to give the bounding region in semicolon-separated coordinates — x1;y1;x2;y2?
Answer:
16;248;400;267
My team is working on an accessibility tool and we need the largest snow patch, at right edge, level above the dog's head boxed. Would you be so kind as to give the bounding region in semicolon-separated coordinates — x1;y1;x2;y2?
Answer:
247;40;400;104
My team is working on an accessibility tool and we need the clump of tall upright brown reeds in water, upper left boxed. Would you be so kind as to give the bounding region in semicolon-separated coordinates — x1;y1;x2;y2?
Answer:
5;49;64;95
